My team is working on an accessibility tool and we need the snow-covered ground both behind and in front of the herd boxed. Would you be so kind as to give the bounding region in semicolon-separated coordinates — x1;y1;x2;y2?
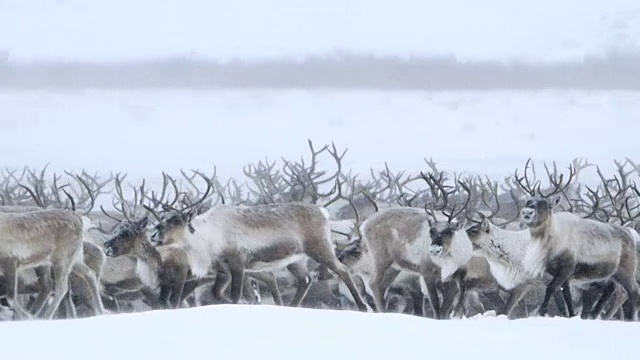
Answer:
0;86;640;354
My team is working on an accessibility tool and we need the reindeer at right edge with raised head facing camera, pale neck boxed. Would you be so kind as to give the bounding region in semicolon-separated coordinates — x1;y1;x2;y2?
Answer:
518;162;640;319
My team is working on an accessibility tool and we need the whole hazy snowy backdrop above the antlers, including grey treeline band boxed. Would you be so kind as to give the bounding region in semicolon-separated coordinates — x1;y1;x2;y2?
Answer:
0;0;640;190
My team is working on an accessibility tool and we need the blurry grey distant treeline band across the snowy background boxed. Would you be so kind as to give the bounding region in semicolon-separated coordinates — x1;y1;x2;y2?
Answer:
0;54;640;90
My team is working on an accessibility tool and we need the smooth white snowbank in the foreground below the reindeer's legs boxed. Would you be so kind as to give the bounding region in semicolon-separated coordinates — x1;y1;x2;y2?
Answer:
0;305;640;360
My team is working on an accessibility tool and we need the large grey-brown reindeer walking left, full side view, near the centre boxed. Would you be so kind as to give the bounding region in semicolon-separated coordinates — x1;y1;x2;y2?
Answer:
148;202;367;310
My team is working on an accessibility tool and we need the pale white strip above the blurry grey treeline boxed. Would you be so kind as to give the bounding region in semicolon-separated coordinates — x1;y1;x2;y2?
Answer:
0;0;640;61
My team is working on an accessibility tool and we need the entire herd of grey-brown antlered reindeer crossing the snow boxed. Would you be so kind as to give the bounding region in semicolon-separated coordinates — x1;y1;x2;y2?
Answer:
0;141;640;320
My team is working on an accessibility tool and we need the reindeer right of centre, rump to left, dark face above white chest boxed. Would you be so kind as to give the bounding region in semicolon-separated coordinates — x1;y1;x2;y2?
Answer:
362;174;472;319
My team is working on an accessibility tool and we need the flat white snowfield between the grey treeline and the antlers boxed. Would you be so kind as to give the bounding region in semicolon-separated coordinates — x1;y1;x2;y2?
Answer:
0;90;640;188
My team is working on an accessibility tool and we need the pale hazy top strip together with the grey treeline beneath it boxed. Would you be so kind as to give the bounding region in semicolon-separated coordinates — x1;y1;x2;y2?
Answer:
0;0;640;90
